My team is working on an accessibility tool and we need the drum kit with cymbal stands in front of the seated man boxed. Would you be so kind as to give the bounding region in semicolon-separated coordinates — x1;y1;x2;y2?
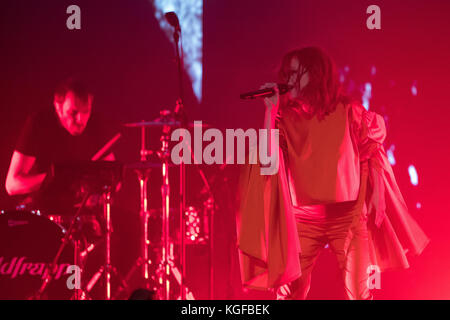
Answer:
0;110;216;300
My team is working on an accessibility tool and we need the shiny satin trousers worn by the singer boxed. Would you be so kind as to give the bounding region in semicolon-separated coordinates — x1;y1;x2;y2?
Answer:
277;163;372;300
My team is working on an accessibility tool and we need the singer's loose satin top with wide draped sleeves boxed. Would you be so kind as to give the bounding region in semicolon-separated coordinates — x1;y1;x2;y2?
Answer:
237;103;429;289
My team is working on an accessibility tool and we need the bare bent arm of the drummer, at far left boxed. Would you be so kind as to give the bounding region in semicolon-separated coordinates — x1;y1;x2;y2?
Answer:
5;150;47;195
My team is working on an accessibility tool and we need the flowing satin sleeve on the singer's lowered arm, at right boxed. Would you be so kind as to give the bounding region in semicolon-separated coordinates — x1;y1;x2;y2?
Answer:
352;105;429;270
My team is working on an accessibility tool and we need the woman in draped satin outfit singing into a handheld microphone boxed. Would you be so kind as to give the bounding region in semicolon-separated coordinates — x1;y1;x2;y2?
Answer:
237;47;429;299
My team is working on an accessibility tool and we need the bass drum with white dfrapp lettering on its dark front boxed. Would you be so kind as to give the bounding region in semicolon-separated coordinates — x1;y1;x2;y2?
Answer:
0;210;74;300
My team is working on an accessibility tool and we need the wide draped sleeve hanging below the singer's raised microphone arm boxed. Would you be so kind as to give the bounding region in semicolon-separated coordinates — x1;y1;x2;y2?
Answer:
236;140;301;290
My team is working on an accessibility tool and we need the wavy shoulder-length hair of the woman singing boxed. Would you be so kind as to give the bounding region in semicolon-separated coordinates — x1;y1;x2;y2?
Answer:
278;47;349;119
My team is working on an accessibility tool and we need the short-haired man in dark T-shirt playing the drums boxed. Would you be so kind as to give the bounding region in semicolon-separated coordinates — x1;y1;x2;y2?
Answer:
5;78;115;214
